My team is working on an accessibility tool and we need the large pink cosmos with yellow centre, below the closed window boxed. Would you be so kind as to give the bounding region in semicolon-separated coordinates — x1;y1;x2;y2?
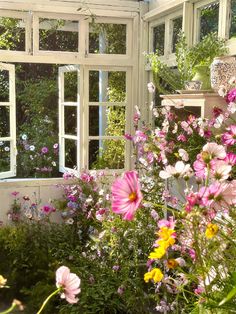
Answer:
111;171;143;220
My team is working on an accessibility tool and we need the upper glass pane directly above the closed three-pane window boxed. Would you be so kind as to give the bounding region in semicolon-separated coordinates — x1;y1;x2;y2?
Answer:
89;23;126;54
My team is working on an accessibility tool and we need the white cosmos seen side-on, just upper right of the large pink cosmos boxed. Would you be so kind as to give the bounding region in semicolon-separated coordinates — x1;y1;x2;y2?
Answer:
159;161;192;179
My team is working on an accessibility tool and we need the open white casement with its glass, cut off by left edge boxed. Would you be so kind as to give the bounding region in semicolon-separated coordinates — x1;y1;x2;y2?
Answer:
0;63;16;179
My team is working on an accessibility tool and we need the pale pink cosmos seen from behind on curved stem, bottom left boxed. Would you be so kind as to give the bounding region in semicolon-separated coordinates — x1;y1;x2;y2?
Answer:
56;266;80;304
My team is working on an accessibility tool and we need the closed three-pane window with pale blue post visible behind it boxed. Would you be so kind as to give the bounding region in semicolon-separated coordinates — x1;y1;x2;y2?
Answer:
84;67;131;171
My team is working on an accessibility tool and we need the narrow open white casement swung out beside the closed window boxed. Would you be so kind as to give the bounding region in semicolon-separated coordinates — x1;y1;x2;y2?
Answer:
59;65;80;172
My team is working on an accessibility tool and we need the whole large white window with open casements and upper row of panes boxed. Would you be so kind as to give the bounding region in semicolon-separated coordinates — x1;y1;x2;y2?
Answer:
0;11;134;178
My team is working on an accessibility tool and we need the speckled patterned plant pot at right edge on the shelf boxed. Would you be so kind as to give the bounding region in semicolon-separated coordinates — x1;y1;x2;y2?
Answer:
211;56;236;92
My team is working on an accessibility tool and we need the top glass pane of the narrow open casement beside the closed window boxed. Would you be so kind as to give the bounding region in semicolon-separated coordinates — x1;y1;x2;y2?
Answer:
64;71;78;102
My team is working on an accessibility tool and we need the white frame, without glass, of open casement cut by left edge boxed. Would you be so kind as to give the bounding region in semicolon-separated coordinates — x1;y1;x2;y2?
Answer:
0;63;17;179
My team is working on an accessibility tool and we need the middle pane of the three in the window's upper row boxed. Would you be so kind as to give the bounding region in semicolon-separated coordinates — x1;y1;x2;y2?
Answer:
39;18;79;52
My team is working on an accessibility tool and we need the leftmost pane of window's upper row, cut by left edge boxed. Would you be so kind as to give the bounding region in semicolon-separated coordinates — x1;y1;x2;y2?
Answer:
0;17;25;51
